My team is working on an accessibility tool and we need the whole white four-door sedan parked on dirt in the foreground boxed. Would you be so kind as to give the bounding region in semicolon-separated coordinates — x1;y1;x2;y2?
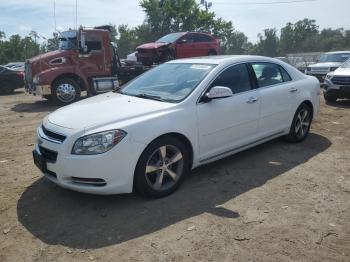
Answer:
33;56;320;197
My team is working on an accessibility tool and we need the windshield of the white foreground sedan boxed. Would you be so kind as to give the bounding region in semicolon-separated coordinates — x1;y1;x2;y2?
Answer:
119;63;215;102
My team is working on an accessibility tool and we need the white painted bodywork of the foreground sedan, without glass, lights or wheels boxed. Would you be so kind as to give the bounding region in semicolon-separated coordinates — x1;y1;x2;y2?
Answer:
36;56;320;194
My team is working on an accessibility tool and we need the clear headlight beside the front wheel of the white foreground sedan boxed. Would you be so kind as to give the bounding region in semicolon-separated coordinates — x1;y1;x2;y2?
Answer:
72;130;127;155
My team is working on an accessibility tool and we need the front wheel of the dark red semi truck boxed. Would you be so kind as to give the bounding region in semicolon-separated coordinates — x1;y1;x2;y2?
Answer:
52;78;80;105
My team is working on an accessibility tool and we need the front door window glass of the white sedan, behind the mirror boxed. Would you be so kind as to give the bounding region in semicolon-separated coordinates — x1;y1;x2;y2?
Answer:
211;64;252;94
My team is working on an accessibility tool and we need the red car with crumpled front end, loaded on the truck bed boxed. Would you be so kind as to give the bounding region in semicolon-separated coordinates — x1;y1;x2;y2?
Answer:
136;32;220;66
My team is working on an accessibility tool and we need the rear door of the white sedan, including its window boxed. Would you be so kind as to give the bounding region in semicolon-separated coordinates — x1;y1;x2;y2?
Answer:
251;62;298;137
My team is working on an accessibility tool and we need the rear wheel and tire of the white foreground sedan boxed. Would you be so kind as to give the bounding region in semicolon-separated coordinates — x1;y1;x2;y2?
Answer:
285;103;312;143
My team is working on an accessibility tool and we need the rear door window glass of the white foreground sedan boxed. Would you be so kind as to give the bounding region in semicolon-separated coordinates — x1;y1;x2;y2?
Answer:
252;63;283;87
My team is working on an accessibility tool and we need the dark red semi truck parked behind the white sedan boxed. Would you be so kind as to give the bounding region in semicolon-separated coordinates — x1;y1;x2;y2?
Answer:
25;26;150;105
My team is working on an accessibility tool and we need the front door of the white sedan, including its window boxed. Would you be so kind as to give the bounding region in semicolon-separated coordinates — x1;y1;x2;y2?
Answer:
197;64;260;162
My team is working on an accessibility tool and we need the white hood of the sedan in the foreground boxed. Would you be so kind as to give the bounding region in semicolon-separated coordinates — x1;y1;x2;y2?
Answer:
47;92;175;129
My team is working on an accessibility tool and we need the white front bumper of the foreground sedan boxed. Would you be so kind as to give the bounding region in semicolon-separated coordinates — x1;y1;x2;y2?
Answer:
35;126;145;194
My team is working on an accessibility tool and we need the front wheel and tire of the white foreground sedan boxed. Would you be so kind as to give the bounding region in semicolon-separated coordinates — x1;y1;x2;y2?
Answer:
134;136;190;198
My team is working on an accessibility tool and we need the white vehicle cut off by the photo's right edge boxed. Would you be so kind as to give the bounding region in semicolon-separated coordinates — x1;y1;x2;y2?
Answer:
322;59;350;102
